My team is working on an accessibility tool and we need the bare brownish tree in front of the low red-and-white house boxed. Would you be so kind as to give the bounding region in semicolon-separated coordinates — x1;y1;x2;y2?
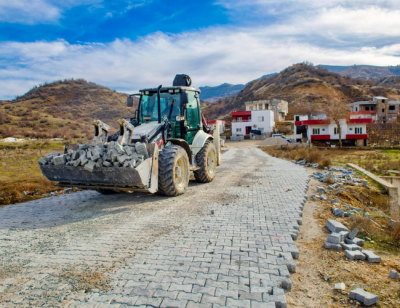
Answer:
319;98;350;148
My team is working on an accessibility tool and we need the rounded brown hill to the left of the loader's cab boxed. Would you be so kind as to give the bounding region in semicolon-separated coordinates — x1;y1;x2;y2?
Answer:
0;79;131;139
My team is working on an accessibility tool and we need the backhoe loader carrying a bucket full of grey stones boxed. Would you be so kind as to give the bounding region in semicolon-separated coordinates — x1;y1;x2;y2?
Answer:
39;74;220;196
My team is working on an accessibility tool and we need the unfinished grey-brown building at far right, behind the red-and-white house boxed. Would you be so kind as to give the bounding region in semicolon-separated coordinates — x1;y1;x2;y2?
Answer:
348;96;400;123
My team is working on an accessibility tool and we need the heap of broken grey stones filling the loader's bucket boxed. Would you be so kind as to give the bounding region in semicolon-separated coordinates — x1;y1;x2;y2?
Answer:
39;141;149;171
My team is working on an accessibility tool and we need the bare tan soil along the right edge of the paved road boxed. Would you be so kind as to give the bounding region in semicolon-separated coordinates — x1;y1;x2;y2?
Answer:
286;170;400;307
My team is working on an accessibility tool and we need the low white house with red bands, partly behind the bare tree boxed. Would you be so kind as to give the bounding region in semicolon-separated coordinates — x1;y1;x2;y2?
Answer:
294;116;373;146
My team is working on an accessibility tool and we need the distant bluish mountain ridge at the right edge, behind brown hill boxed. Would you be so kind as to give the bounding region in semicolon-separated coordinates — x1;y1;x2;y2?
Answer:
317;65;400;80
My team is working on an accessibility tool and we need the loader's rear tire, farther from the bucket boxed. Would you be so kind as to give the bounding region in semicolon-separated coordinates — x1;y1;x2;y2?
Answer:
193;140;217;183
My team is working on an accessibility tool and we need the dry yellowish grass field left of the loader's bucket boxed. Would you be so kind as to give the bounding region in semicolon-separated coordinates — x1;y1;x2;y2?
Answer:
0;142;64;206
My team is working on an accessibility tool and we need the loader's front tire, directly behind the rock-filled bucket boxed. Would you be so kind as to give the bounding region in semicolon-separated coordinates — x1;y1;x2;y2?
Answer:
158;145;190;196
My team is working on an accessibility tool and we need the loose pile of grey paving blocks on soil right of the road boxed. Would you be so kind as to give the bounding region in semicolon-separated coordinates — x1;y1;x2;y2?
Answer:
324;219;381;263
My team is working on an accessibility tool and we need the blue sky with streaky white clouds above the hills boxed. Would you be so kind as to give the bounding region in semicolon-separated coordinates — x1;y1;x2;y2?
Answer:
0;0;400;99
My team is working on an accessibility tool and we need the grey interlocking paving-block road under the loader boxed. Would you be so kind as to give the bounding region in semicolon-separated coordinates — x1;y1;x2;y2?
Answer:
0;147;308;308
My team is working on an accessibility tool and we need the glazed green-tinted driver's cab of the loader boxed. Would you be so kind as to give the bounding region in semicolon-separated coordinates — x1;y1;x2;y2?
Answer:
132;87;202;144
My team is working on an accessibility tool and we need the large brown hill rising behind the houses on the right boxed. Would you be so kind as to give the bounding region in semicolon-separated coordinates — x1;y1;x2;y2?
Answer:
207;64;400;120
